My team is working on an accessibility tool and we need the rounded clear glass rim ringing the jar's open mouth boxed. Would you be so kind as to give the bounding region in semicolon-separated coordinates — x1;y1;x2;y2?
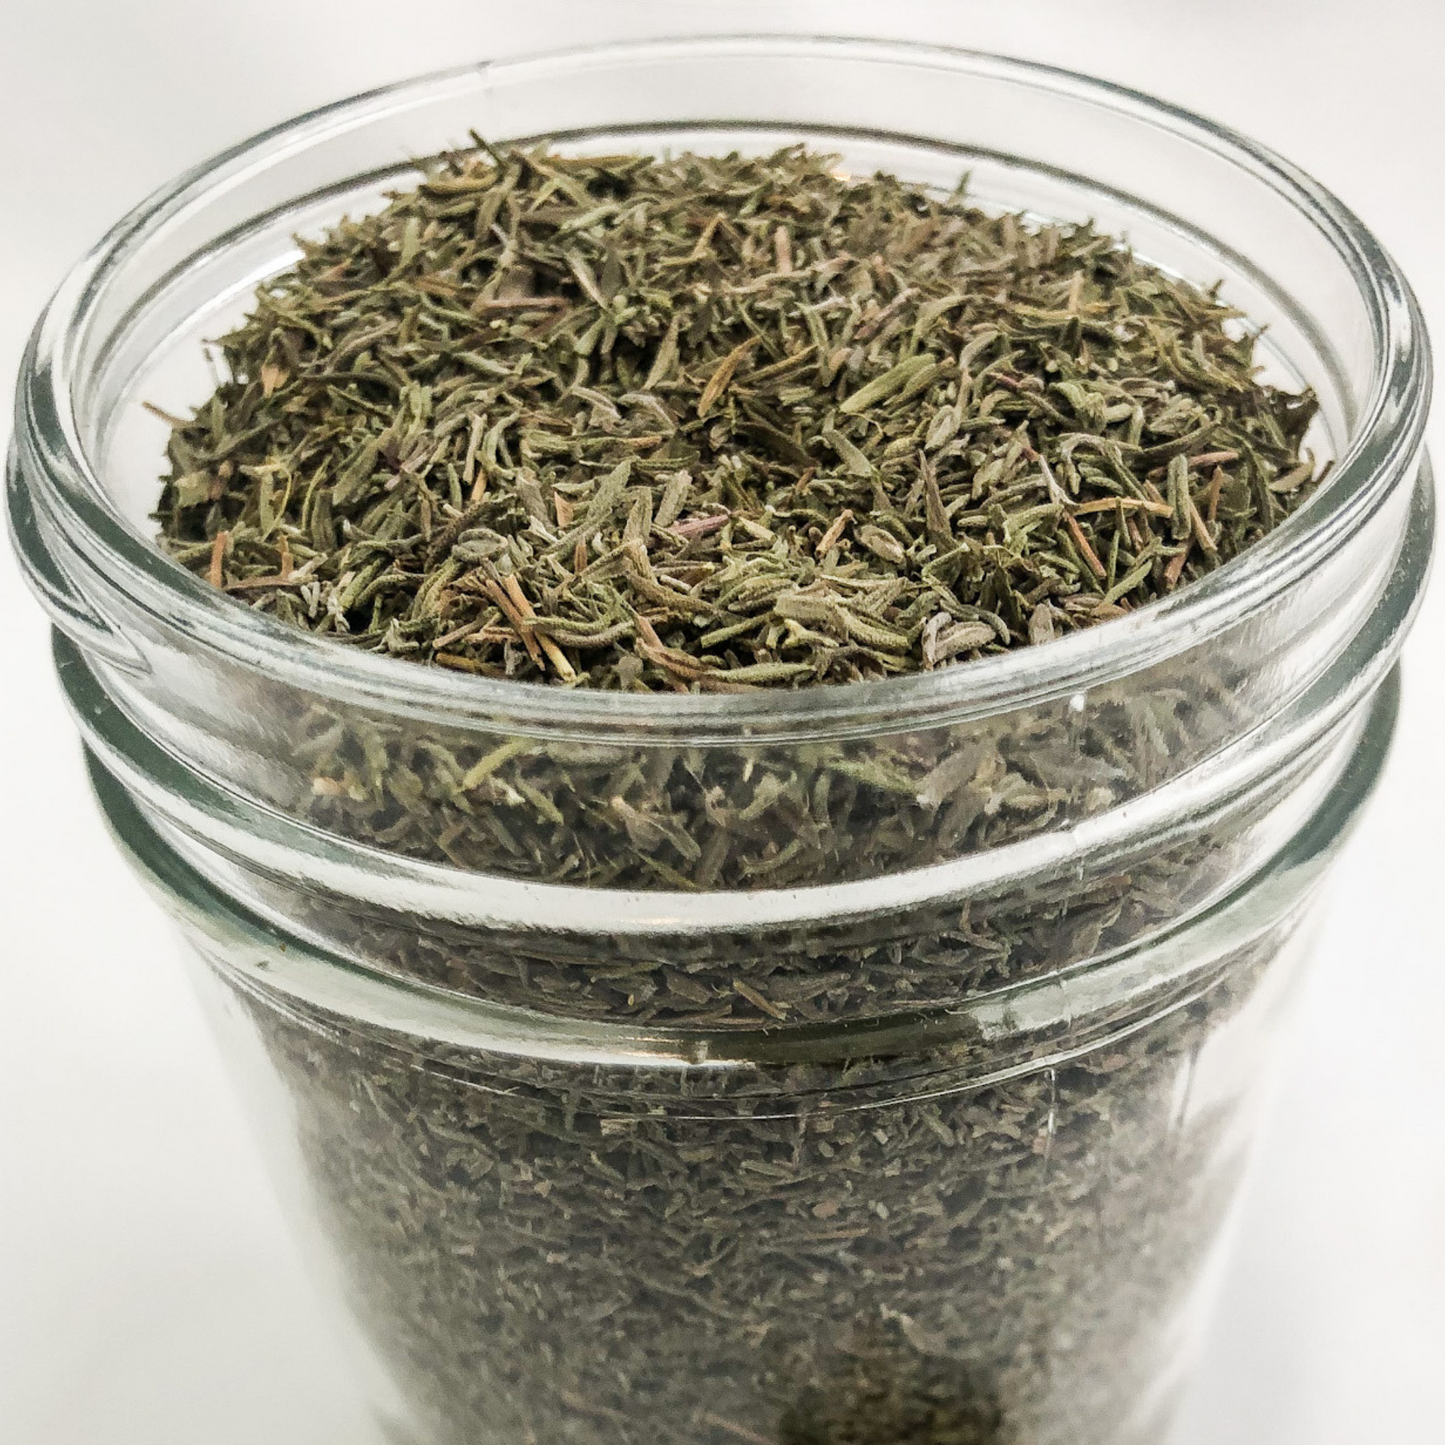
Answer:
16;36;1431;743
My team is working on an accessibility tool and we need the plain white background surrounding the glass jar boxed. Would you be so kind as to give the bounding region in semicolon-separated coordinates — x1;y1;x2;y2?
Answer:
0;0;1445;1445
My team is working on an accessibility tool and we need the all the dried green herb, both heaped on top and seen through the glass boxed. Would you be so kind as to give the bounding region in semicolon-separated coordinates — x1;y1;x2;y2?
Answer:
140;146;1324;1445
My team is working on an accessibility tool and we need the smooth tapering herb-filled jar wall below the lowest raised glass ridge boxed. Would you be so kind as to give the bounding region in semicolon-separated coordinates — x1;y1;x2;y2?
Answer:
189;933;1289;1445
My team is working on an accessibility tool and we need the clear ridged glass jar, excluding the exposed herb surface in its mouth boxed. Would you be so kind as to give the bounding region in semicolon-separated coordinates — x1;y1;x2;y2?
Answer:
7;38;1432;1445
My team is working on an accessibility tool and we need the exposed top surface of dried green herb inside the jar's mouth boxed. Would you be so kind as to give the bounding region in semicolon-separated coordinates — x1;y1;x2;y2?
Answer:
159;147;1316;691
